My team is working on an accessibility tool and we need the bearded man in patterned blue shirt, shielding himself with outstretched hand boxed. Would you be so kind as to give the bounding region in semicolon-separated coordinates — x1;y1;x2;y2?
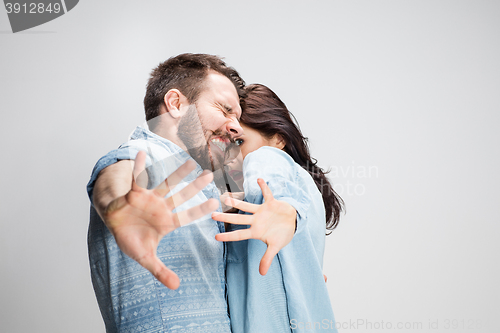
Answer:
88;54;296;332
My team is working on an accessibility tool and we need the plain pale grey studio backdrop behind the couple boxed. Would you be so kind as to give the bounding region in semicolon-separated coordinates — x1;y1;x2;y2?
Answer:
0;0;500;333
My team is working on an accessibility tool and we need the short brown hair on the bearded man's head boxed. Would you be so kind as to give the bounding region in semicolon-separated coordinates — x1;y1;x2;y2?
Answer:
144;53;245;121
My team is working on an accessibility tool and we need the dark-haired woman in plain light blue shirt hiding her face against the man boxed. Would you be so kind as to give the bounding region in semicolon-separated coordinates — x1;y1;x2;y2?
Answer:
214;84;343;333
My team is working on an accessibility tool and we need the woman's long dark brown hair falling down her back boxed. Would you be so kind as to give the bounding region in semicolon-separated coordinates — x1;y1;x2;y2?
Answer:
240;84;344;230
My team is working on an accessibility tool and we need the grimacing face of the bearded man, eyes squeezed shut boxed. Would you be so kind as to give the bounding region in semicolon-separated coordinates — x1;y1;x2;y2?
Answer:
177;73;243;171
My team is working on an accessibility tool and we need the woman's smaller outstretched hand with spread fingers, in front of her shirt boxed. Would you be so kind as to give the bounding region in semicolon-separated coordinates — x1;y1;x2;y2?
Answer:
212;178;297;275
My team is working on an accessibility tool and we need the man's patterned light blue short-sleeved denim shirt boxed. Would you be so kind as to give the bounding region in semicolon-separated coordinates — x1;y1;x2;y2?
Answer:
87;128;230;333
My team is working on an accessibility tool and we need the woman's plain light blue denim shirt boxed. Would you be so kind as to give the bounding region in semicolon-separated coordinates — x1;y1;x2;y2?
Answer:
226;147;337;333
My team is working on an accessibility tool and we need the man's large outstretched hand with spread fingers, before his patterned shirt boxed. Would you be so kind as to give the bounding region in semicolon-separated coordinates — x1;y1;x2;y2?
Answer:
103;152;219;289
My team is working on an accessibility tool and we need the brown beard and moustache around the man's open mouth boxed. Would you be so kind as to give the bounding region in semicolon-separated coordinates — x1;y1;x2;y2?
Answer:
177;104;235;192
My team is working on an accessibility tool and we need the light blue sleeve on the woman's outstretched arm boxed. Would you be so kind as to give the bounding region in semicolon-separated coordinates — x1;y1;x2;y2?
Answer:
243;146;311;232
